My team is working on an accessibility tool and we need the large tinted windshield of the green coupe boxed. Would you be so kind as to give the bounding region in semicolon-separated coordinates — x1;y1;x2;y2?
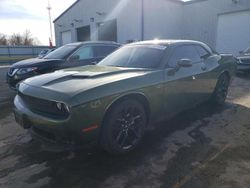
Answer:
98;45;166;68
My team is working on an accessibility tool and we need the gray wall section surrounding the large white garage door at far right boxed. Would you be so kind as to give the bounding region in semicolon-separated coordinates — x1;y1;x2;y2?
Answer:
182;0;250;48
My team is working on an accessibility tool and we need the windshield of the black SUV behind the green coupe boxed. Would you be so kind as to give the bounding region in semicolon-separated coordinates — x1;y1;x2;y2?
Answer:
44;45;77;59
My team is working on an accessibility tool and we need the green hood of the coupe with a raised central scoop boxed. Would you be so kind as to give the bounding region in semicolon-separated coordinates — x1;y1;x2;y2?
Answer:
19;65;155;105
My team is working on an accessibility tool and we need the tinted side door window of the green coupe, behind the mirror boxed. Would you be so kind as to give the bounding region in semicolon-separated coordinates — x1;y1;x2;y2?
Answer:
168;45;201;67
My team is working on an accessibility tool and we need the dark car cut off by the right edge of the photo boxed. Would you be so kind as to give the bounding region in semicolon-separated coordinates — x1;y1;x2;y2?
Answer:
237;46;250;73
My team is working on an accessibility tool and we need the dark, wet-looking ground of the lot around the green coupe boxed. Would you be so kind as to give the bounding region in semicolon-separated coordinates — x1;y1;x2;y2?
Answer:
0;67;250;188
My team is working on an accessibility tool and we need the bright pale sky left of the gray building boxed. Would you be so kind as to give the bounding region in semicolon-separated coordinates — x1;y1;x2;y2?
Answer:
0;0;76;45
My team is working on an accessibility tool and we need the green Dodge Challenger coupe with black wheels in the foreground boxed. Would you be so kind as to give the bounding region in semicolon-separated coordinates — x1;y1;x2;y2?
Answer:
14;40;236;153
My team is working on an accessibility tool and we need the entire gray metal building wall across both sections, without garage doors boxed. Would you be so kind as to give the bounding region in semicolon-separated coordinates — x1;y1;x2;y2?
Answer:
55;0;250;48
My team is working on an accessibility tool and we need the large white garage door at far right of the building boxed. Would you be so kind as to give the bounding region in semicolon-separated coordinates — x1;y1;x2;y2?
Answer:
216;11;250;55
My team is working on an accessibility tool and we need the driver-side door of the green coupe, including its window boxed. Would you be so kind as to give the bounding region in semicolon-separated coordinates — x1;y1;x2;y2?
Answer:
164;45;205;115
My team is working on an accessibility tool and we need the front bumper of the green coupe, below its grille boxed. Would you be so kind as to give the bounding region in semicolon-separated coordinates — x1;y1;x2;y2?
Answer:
14;95;97;151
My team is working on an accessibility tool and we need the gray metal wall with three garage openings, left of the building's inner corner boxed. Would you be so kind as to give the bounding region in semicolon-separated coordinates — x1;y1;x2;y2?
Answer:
54;0;182;46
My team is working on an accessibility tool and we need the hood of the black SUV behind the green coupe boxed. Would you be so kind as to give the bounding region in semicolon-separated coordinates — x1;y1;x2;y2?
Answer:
12;58;61;68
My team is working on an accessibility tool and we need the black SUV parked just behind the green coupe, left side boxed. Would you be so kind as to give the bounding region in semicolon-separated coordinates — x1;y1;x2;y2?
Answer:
6;42;121;89
